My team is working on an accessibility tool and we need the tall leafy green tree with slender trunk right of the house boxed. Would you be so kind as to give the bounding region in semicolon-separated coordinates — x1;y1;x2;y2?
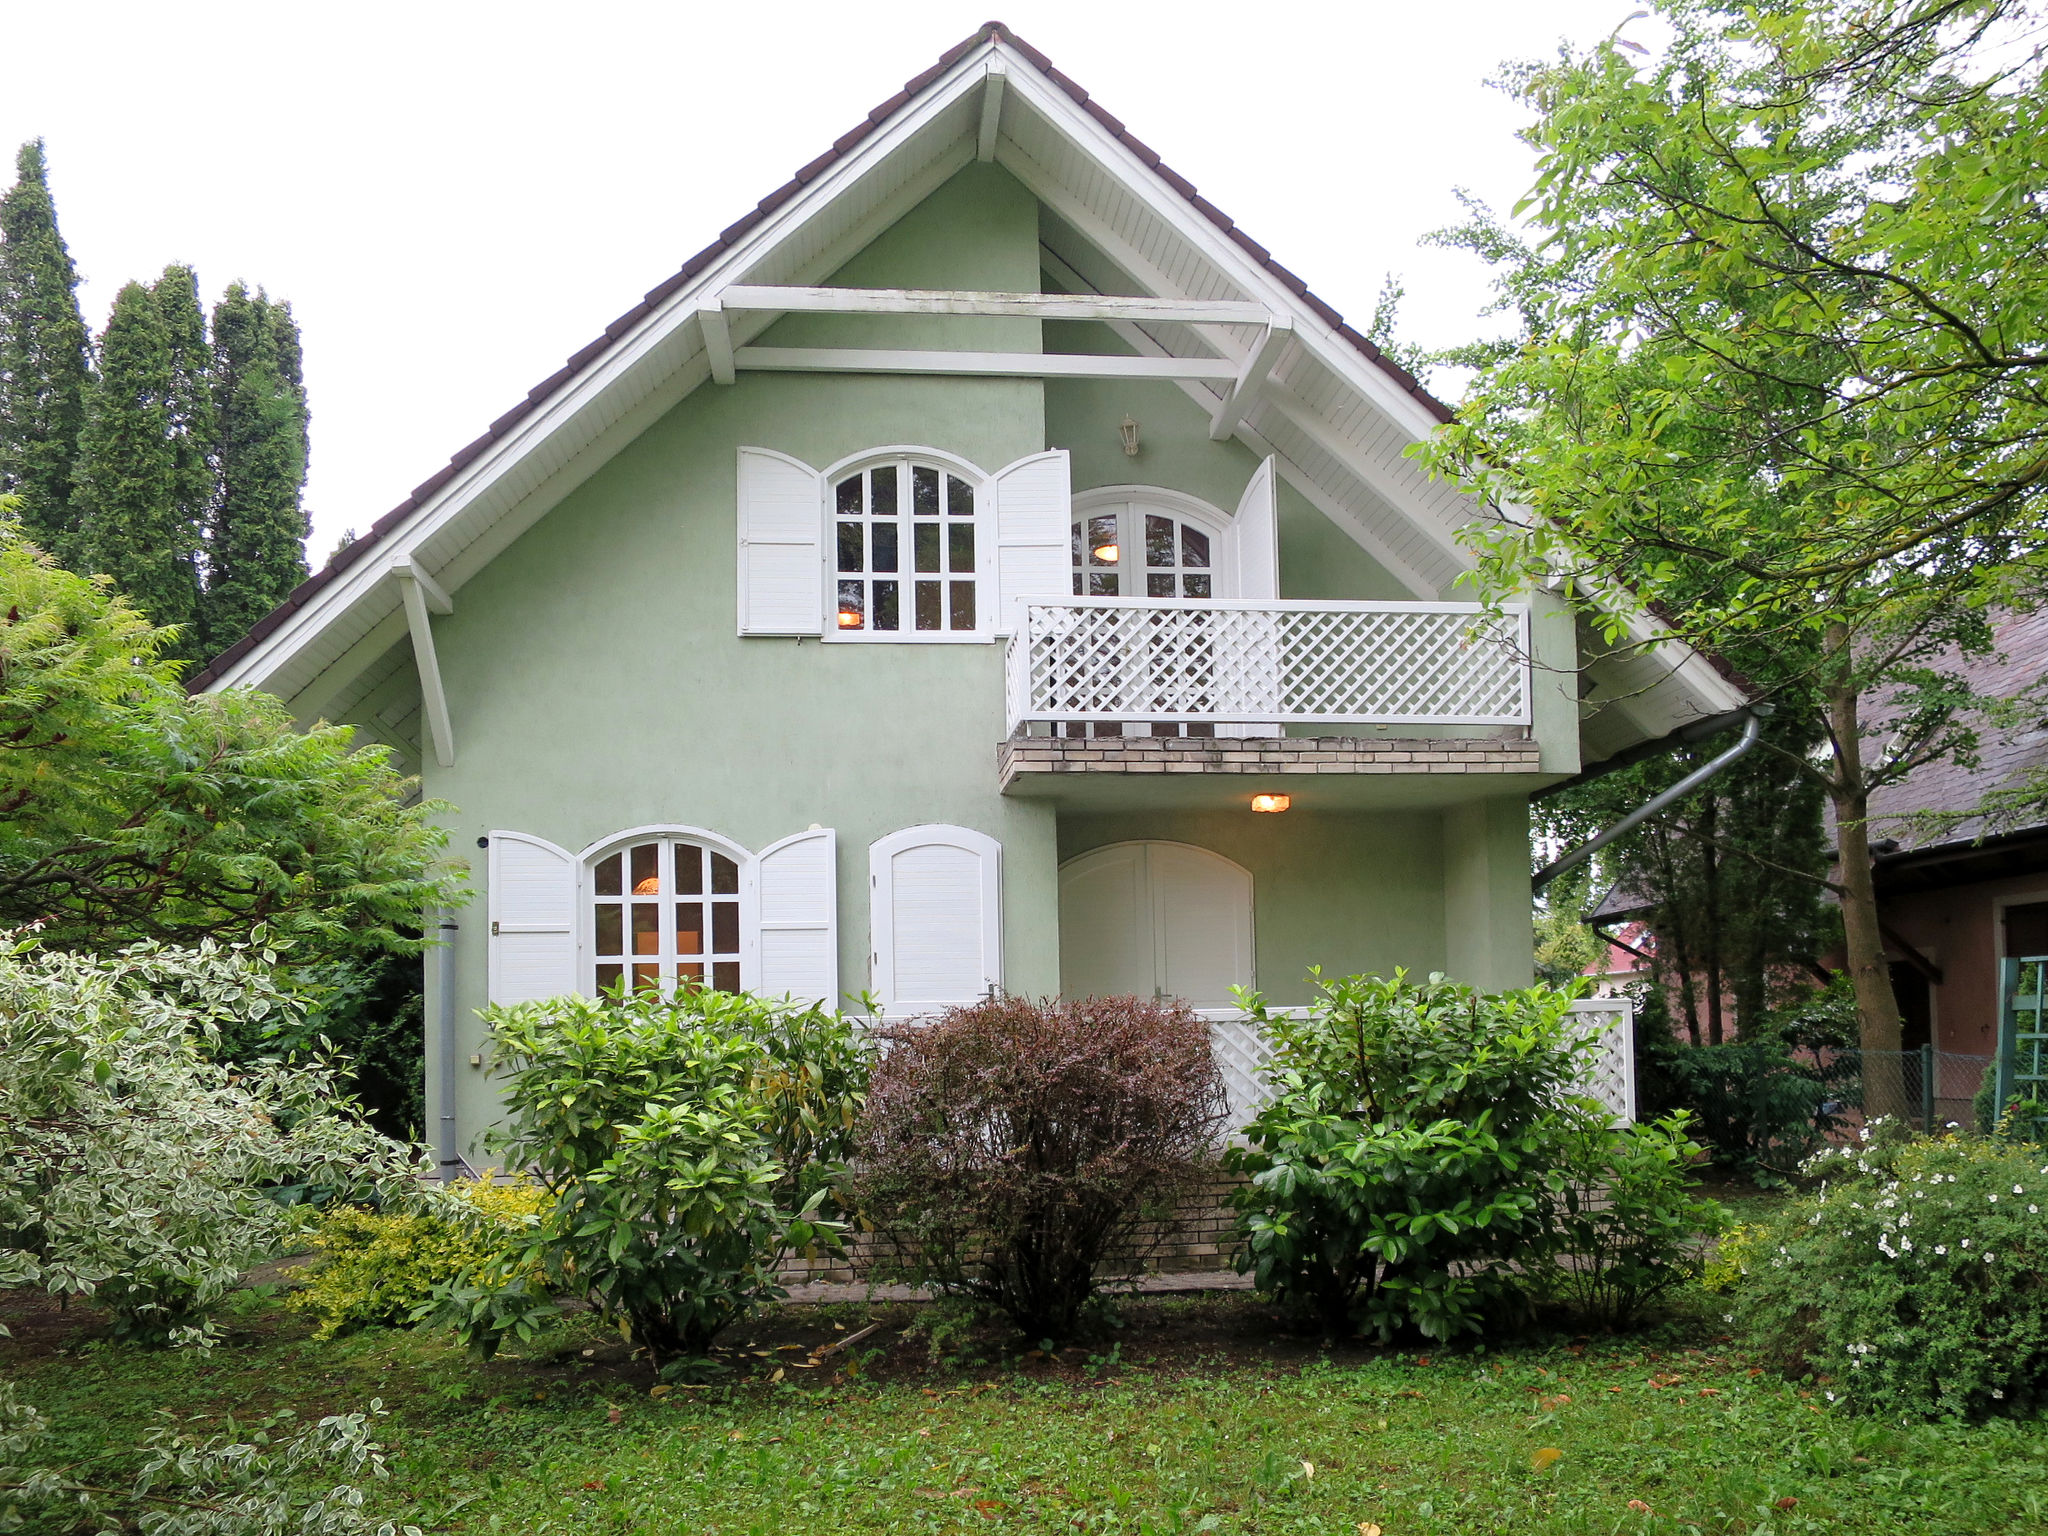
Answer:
1423;0;2048;1051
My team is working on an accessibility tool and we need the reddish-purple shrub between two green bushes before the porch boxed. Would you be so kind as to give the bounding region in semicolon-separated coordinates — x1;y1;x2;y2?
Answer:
856;997;1225;1339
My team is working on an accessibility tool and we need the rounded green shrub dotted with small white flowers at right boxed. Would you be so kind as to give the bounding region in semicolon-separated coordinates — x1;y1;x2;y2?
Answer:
1729;1122;2048;1419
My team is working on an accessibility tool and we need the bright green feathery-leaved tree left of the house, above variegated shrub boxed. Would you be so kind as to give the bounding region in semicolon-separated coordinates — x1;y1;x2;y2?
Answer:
0;508;465;967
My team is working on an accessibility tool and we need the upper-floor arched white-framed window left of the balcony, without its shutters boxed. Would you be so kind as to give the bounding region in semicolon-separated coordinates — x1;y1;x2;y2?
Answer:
829;457;991;639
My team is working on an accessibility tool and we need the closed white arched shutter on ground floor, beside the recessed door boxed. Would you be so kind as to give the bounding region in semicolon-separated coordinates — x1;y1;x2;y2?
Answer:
868;825;1004;1018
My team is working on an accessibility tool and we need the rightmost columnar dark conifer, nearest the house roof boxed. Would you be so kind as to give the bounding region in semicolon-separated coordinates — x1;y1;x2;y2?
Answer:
207;283;307;653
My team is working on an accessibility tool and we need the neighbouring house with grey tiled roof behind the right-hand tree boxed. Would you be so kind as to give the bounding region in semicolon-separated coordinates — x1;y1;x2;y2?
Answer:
1870;612;2048;1057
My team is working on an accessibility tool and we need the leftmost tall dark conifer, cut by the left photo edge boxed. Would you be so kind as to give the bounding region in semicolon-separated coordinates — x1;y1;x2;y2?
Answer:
0;139;92;557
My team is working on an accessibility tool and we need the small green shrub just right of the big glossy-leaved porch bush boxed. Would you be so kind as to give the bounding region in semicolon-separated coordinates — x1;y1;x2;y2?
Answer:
1530;1114;1726;1327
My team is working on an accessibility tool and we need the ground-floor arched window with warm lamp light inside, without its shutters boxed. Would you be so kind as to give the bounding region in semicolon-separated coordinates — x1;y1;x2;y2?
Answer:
590;836;741;991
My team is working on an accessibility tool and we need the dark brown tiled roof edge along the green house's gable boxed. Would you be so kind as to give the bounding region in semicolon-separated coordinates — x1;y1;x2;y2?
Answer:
186;20;1452;692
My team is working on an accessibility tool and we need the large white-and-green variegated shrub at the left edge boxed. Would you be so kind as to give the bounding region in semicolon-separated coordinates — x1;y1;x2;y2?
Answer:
0;940;420;1343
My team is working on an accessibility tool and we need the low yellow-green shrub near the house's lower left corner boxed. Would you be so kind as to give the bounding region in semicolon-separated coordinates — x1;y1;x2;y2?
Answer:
291;1180;547;1339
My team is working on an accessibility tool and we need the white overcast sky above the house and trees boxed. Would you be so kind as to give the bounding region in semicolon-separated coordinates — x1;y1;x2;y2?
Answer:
0;0;1657;565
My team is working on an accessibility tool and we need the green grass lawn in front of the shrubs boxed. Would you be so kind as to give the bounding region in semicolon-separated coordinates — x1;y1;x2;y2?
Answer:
0;1294;2048;1536
